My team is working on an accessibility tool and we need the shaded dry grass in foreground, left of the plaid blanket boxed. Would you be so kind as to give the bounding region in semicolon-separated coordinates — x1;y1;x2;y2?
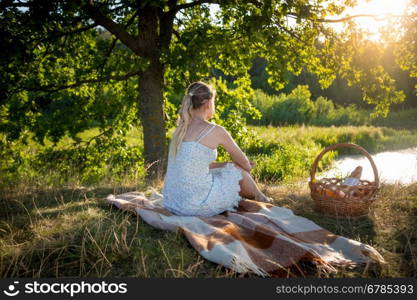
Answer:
0;186;240;278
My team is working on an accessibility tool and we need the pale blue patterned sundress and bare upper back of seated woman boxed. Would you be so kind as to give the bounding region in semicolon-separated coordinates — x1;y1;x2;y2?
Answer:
163;123;243;216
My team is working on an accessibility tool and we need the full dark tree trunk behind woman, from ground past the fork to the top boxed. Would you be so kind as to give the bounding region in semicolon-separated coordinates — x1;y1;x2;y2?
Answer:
138;5;173;184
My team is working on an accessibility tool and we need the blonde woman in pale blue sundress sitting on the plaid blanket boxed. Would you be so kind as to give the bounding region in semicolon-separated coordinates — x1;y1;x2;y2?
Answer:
163;81;271;216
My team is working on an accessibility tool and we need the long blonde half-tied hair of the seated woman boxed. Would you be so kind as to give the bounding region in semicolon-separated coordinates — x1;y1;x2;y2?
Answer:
169;81;216;158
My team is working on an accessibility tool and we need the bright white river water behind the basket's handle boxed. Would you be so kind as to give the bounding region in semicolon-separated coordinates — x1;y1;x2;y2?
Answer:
316;147;417;184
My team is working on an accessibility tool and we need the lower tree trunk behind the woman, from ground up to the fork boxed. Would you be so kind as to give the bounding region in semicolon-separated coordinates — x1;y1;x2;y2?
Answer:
139;56;167;183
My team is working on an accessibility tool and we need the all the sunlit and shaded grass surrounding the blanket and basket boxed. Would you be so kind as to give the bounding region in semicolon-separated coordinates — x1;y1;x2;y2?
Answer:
0;126;417;278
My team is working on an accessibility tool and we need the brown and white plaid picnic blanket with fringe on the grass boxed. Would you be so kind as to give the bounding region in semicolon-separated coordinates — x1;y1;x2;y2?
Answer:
106;190;385;277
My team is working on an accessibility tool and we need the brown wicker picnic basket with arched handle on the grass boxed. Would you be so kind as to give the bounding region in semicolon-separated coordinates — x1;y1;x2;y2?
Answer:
309;143;379;218
